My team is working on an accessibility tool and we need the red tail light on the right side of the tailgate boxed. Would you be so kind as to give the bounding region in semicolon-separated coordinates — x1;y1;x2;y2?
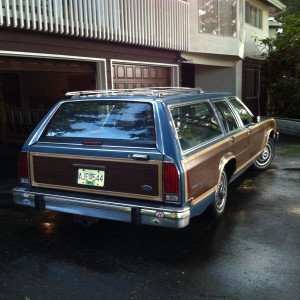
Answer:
164;163;179;202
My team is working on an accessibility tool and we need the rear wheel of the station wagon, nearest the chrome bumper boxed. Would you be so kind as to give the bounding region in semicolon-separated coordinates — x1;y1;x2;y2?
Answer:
210;170;228;218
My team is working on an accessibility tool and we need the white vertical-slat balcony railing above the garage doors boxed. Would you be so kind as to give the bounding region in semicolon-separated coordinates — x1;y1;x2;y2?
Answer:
0;0;189;51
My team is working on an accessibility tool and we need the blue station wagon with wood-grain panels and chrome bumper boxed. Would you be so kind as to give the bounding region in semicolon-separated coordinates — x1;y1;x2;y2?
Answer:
13;88;278;228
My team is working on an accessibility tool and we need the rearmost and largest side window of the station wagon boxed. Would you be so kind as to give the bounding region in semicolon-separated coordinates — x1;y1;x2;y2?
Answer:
171;102;222;151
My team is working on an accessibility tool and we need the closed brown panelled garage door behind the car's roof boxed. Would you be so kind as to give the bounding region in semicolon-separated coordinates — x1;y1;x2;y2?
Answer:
112;64;171;89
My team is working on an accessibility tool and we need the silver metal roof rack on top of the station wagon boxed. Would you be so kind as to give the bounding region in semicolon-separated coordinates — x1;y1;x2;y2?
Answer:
66;87;204;98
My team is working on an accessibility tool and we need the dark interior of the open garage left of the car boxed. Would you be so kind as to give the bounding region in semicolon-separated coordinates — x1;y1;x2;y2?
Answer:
0;57;96;144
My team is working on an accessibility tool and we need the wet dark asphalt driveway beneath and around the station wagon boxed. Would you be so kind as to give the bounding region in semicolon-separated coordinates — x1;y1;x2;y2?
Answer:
0;136;300;300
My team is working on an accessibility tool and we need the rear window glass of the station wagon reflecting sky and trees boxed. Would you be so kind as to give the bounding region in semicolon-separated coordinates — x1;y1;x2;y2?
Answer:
43;101;155;142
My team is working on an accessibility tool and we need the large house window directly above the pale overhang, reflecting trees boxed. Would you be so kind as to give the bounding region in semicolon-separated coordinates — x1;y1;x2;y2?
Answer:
198;0;237;37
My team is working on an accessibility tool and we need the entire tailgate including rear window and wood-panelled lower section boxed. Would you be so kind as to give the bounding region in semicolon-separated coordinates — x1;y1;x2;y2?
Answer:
26;97;163;201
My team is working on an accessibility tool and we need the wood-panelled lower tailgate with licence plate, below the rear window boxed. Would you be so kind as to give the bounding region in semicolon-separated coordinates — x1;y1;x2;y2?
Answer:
30;143;163;201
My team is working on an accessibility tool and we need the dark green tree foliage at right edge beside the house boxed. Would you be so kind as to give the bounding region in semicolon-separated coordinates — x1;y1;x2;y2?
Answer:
261;14;300;118
